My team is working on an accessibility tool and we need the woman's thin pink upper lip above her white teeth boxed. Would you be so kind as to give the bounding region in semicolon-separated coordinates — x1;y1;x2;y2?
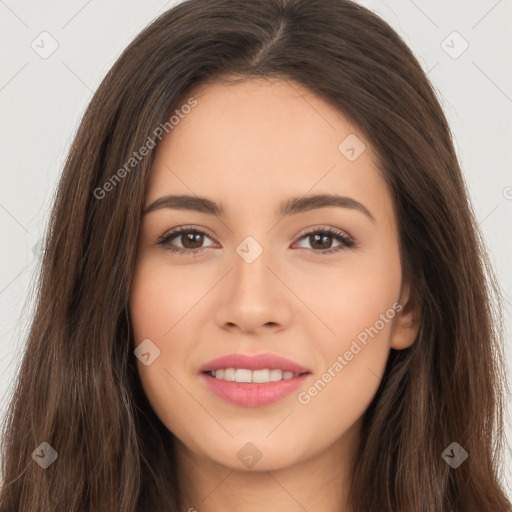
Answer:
199;353;311;374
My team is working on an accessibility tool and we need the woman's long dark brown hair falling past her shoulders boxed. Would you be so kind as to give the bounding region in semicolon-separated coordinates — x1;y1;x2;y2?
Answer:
0;0;511;512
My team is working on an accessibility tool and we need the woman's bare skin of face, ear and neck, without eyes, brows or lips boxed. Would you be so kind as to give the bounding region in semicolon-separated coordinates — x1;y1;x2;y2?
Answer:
130;78;419;512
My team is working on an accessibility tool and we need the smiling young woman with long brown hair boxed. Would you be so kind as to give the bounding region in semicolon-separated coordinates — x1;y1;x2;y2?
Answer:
0;0;511;512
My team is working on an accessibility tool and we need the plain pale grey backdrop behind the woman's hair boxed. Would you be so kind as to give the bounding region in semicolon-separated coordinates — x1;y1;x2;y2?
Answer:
0;0;512;495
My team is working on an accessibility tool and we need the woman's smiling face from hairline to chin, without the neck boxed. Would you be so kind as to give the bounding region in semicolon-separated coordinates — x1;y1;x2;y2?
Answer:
130;79;415;470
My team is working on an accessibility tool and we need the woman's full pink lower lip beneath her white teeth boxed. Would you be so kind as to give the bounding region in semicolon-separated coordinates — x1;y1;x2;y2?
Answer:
200;373;311;407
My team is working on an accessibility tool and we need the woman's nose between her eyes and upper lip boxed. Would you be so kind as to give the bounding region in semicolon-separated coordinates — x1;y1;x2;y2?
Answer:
216;241;293;334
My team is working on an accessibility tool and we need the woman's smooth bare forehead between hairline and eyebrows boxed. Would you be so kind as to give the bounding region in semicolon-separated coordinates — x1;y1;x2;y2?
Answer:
146;78;393;226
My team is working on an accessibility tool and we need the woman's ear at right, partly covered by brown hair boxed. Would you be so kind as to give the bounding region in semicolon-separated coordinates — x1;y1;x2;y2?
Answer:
391;281;421;350
